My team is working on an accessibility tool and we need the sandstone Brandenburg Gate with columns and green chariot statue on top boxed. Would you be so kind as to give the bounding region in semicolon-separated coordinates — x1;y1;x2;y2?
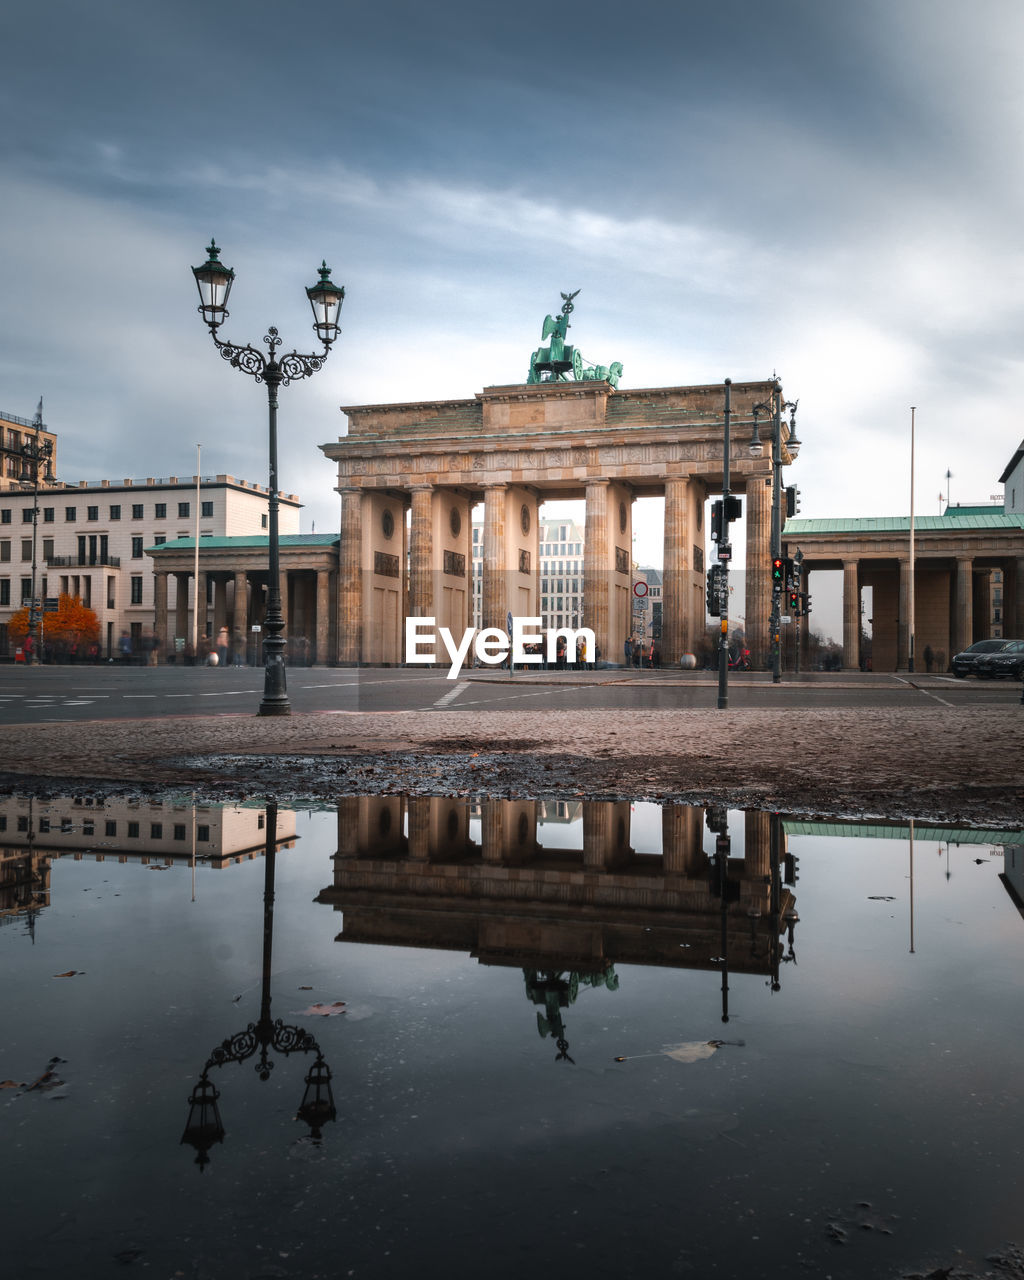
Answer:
321;294;790;666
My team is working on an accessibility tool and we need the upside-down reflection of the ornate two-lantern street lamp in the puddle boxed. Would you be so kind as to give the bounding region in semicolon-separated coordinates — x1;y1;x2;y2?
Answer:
182;801;337;1172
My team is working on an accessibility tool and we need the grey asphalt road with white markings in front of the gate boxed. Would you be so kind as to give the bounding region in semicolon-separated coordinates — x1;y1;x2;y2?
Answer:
0;666;1020;726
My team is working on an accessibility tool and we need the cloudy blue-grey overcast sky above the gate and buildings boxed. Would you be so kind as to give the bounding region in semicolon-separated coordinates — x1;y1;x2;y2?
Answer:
0;0;1024;581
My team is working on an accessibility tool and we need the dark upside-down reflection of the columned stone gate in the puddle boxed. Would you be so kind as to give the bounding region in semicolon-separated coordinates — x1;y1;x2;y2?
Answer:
317;796;794;974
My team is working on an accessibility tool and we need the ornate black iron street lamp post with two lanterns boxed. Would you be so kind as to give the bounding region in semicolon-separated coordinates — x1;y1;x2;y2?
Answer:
192;241;344;716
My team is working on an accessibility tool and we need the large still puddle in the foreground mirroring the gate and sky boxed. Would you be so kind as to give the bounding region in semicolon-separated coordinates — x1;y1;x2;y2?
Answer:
0;795;1024;1280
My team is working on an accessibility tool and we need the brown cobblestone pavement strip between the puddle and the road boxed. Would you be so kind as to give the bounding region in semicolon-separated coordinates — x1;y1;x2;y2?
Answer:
0;705;1024;827
